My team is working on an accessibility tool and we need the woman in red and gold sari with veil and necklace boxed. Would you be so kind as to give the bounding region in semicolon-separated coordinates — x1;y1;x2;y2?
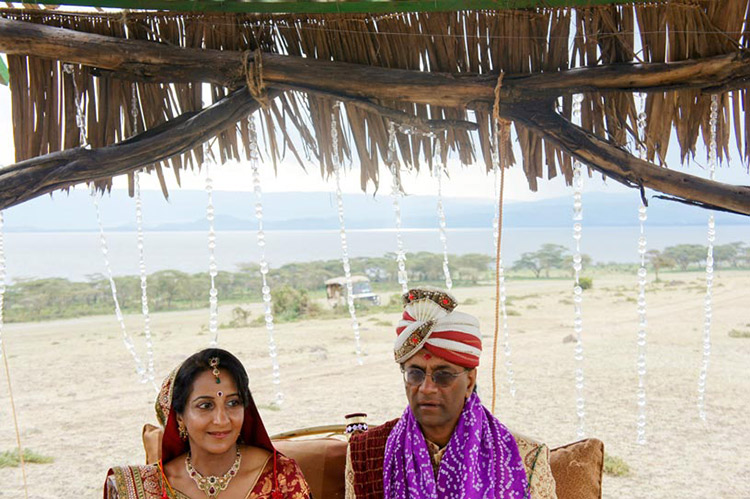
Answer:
104;348;311;499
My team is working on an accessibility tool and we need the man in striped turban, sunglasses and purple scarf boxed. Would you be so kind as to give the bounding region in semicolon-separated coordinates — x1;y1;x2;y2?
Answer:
346;287;555;499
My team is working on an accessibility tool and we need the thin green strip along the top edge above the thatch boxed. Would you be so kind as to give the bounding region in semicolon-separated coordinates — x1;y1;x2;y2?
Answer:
25;0;664;14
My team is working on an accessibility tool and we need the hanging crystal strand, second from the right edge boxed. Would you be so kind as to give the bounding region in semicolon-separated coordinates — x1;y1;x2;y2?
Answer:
636;95;648;445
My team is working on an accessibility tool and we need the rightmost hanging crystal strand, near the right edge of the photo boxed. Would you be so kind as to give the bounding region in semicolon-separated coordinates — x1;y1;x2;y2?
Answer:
698;94;719;421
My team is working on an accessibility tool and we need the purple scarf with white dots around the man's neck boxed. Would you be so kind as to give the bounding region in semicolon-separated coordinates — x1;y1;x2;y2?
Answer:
383;393;528;499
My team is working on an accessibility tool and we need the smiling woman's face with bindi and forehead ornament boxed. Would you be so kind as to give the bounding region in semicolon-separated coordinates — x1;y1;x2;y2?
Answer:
178;369;245;454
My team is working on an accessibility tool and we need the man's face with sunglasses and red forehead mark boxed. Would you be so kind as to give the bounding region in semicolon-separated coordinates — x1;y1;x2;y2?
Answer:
402;349;477;442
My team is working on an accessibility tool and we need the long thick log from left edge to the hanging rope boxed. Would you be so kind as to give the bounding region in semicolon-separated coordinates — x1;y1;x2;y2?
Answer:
0;18;496;107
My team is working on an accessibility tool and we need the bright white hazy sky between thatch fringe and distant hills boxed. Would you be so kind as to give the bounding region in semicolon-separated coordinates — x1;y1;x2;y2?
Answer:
0;63;750;201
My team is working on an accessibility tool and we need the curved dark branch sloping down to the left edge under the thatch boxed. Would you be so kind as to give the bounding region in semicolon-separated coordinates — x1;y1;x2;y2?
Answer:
0;88;268;210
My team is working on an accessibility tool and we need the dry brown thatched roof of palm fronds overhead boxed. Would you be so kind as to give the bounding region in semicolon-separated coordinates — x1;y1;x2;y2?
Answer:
0;0;750;212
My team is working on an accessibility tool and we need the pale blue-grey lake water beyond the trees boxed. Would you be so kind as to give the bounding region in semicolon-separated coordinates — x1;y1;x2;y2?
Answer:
4;225;750;281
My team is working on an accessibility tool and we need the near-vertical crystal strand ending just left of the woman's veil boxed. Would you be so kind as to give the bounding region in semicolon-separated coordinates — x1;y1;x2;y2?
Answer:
130;83;159;391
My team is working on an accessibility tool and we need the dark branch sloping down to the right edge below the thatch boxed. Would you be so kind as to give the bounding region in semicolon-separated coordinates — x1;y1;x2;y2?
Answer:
505;102;750;215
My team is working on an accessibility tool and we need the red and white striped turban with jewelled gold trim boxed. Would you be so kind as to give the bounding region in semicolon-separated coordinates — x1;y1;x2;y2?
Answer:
393;287;482;369
